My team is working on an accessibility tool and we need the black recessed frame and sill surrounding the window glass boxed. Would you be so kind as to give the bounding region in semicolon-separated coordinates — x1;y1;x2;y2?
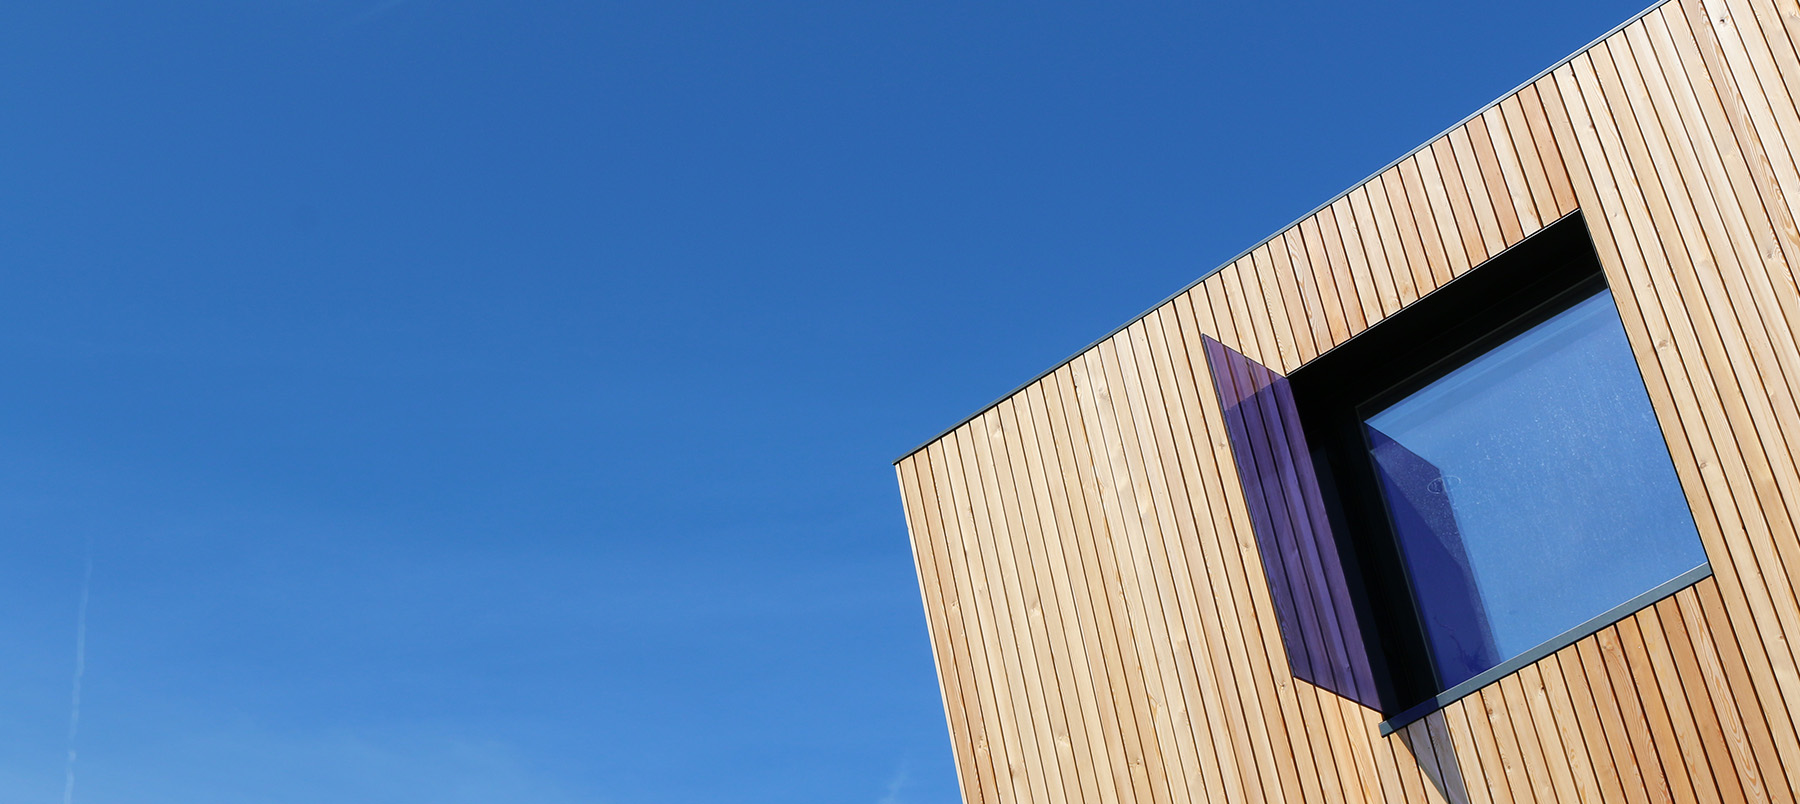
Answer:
1289;212;1710;723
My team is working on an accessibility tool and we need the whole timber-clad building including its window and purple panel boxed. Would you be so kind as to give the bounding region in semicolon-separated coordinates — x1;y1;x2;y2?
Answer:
896;0;1800;804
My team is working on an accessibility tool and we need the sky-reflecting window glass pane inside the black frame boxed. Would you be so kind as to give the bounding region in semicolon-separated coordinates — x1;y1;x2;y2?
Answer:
1364;291;1705;687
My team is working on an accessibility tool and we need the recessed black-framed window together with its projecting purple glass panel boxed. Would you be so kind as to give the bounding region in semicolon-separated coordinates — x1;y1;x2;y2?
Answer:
1208;214;1706;714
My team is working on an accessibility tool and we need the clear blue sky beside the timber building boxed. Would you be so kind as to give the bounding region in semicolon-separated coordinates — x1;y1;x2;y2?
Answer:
0;0;1642;804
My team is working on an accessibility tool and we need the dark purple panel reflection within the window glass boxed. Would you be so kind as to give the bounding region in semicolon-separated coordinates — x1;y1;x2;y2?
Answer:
1364;424;1503;687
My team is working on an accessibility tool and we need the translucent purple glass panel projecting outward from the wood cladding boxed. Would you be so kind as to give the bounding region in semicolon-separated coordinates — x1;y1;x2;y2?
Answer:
1206;338;1379;709
